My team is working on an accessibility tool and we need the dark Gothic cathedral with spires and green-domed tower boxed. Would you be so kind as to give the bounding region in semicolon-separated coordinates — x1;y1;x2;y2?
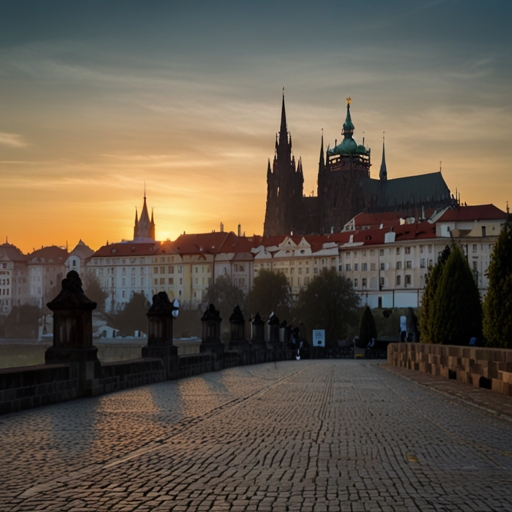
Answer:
263;96;454;236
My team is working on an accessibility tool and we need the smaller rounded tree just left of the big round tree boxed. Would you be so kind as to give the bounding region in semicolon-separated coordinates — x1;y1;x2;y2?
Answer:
247;269;291;320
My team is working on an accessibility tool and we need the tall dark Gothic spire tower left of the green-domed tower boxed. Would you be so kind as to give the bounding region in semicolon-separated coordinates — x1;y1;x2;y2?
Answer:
263;89;304;236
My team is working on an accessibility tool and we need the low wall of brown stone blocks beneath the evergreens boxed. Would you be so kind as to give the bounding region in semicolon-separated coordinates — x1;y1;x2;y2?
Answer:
388;343;512;396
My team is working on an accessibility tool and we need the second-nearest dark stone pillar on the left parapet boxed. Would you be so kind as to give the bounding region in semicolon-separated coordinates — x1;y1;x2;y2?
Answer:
142;292;179;379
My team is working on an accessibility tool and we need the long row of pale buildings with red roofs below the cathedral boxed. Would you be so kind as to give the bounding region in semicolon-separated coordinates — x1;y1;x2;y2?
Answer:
0;199;507;315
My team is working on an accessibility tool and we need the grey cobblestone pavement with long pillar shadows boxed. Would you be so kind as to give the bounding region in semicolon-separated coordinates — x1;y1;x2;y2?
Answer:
0;360;512;512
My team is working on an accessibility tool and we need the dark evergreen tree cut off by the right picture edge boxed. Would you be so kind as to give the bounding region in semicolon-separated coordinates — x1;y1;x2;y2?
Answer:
483;215;512;348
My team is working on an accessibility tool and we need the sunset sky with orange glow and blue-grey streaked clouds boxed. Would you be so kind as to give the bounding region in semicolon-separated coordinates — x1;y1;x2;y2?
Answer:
0;0;512;252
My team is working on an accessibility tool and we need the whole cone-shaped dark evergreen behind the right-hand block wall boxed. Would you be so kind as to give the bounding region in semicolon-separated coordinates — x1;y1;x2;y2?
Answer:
429;244;482;345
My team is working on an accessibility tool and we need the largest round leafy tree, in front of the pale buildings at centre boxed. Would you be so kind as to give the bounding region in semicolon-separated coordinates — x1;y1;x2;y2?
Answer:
294;268;359;348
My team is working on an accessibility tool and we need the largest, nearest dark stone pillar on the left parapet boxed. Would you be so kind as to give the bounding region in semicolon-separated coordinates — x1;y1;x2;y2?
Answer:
45;270;101;395
